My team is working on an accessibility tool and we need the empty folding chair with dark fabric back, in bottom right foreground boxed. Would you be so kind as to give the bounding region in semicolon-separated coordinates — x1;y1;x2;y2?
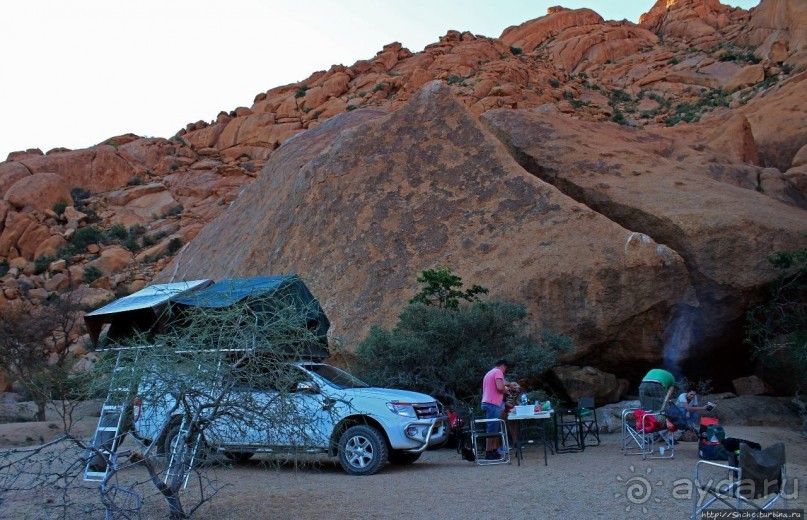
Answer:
690;442;787;520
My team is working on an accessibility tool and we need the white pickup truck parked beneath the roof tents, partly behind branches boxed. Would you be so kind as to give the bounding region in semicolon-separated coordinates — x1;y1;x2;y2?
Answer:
132;361;448;475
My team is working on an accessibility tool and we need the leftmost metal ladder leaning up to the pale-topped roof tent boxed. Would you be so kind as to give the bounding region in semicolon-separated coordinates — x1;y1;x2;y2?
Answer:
84;350;137;482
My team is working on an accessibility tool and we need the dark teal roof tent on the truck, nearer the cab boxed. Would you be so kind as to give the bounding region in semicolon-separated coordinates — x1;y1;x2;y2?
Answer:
171;274;331;359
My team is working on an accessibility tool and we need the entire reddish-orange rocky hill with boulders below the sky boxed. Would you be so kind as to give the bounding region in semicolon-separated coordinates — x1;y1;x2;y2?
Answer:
0;0;807;390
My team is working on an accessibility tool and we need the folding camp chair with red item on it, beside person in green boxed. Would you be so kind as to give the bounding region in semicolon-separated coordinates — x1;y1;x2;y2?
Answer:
622;408;675;460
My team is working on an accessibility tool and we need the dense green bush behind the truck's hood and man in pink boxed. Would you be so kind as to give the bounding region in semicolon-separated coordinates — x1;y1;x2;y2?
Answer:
356;301;571;405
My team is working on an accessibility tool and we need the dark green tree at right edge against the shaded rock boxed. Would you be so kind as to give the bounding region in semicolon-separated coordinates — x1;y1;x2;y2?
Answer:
746;242;807;391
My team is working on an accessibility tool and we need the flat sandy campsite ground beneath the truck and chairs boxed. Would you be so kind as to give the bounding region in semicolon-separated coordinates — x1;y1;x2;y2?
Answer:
0;419;807;520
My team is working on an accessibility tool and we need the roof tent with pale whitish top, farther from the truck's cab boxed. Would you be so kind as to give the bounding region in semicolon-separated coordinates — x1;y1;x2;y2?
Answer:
84;280;213;346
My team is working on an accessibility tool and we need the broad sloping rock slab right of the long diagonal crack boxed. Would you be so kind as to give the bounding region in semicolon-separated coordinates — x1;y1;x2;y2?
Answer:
482;106;807;382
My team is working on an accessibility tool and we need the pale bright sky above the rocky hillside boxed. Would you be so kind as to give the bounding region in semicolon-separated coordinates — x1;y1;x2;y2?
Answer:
0;0;759;161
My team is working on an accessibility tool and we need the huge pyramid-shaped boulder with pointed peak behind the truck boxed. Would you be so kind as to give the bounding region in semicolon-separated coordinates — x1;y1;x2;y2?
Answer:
159;83;691;372
